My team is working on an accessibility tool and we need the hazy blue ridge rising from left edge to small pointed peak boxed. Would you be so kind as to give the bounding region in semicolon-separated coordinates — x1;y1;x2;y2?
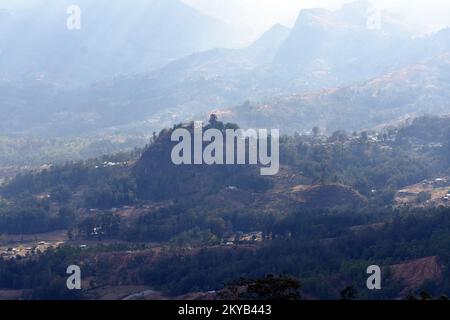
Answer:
0;21;289;136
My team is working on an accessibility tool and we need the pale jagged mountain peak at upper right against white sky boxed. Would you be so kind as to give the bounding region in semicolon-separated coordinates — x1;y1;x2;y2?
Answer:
275;0;407;67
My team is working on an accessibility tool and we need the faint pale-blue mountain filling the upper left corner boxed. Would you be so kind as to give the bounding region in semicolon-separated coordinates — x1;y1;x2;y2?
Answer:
0;0;236;85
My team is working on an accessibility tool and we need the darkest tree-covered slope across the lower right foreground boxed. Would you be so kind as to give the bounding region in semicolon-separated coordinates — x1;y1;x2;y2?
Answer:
142;209;450;299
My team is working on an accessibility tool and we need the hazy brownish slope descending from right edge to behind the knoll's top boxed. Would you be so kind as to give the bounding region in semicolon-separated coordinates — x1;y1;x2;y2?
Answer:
220;53;450;133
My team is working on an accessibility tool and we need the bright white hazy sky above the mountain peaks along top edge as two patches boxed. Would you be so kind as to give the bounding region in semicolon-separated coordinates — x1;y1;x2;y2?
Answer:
183;0;450;41
